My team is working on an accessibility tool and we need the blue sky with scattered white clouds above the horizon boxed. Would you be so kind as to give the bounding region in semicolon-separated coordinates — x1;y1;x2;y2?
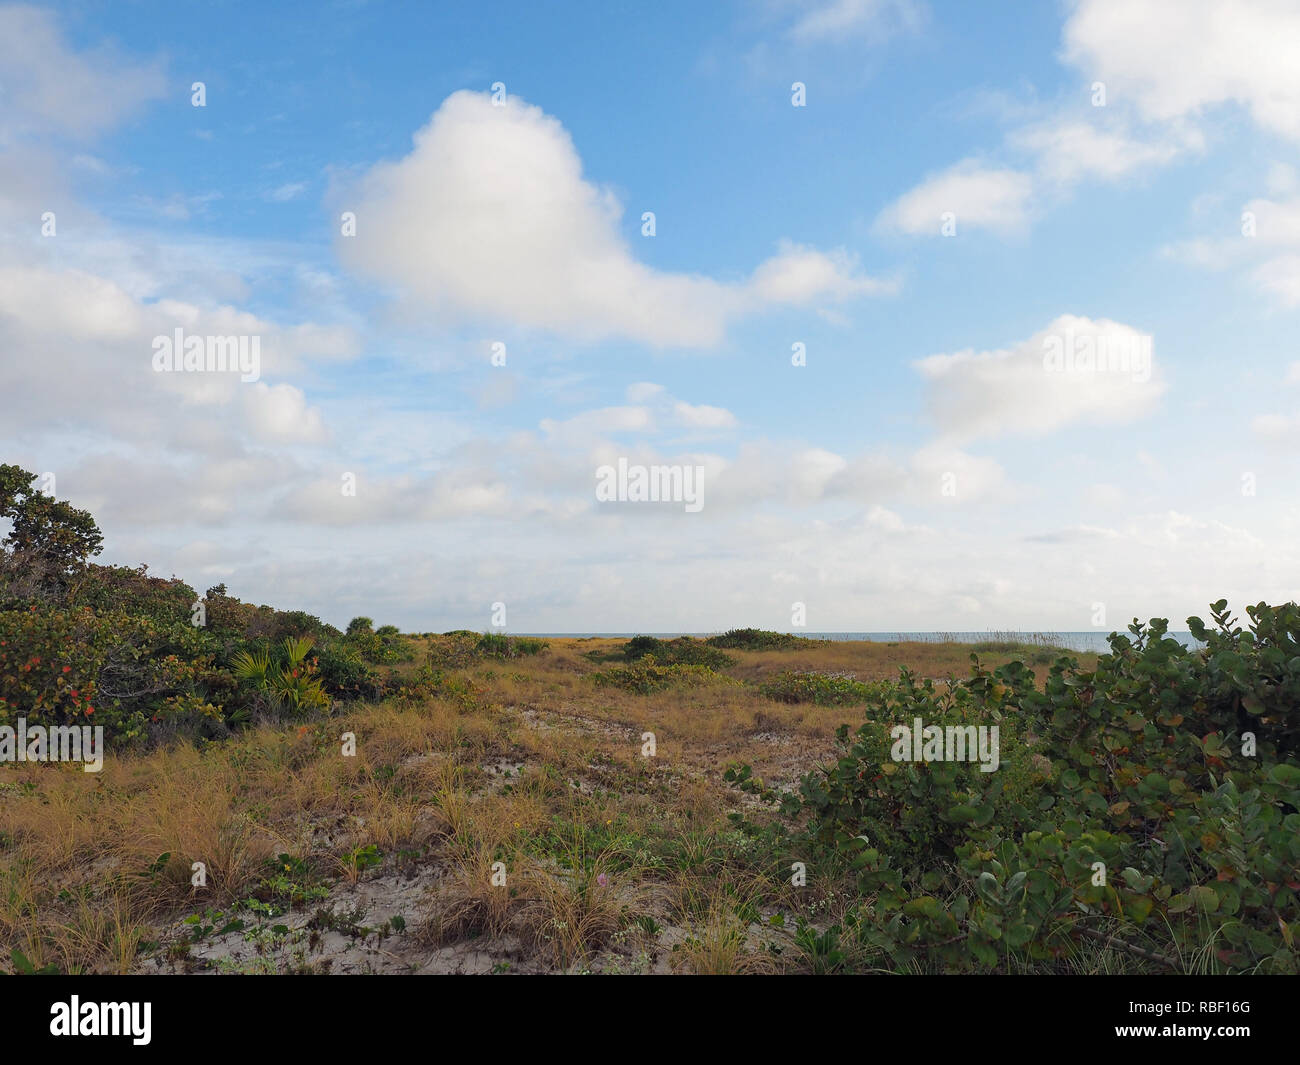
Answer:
0;0;1300;632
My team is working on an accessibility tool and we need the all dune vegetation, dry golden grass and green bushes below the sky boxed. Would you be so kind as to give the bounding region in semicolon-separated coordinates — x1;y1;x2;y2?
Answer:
0;467;1300;974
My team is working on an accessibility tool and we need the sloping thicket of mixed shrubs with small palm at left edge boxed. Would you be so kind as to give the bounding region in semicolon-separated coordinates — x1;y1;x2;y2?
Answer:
0;466;413;740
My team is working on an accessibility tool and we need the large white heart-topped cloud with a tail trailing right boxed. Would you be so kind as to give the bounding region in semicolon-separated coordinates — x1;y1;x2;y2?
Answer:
338;91;888;346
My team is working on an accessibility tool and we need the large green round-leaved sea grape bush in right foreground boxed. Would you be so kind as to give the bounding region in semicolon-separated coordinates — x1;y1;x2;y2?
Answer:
727;601;1300;973
